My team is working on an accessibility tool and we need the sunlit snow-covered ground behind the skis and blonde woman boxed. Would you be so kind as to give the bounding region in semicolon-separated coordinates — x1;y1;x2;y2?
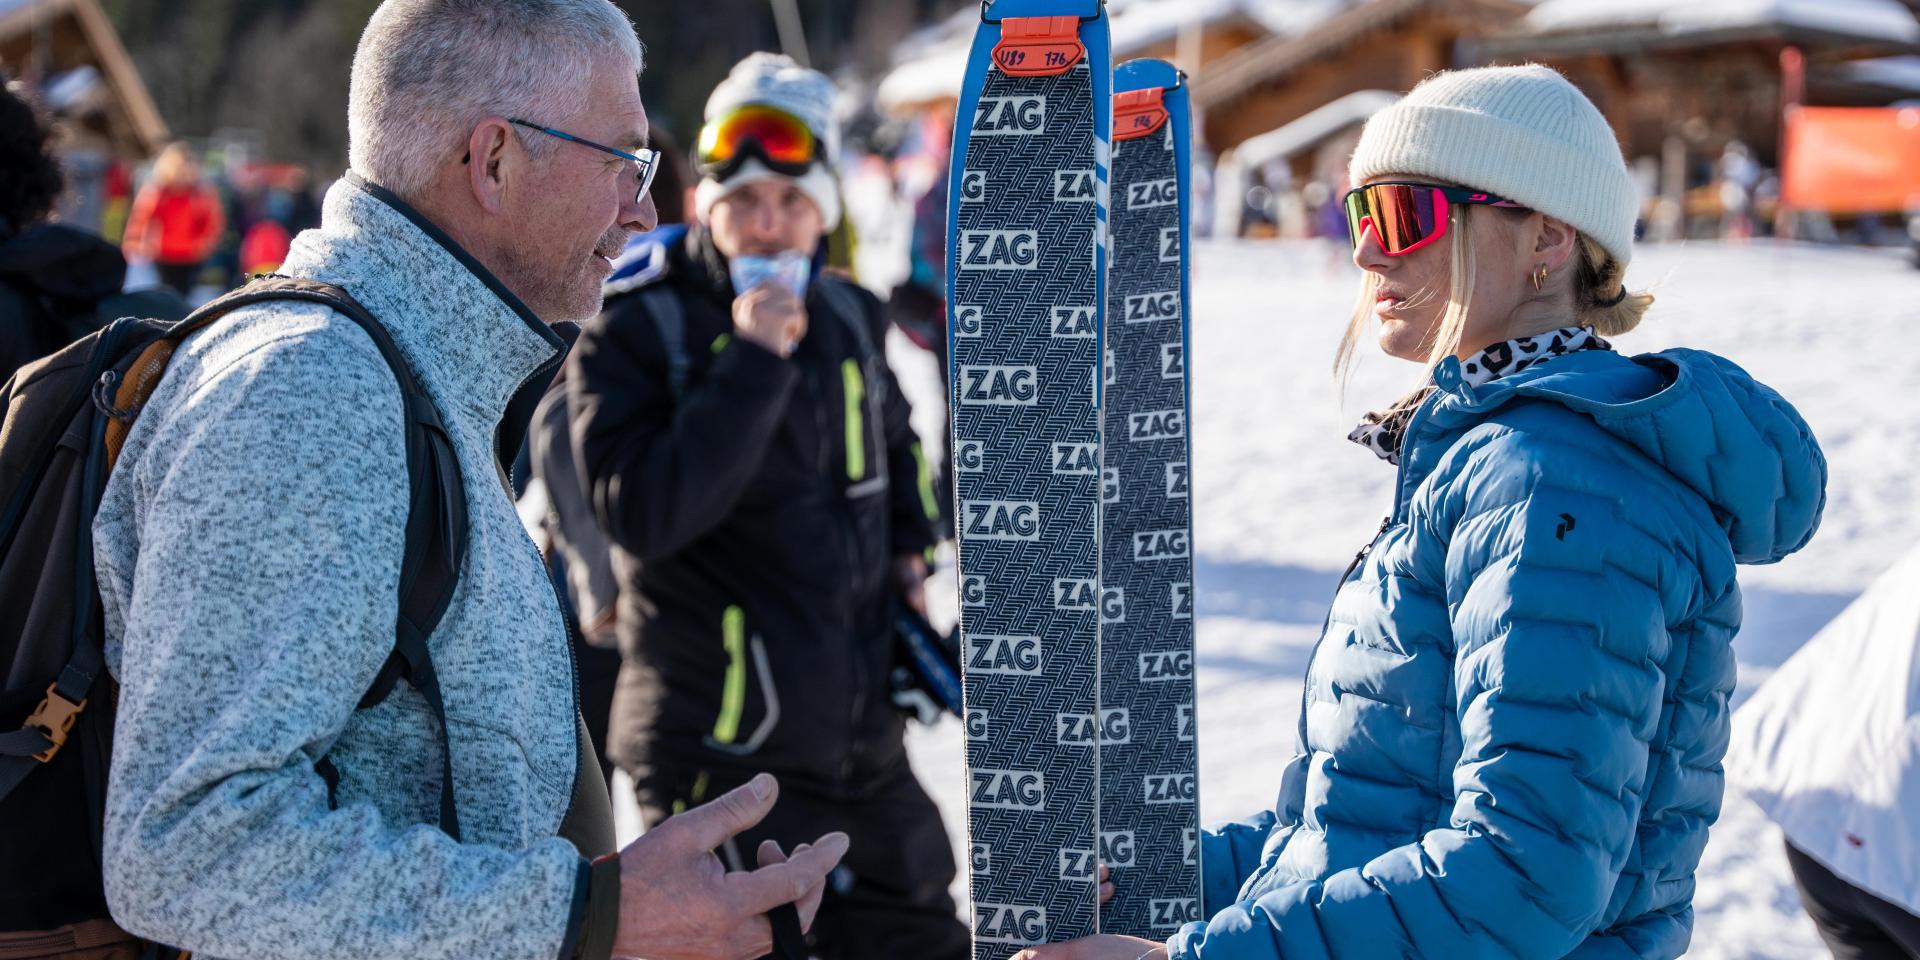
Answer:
893;242;1920;958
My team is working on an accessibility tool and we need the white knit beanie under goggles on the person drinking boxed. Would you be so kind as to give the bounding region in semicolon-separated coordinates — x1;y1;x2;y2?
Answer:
693;54;841;232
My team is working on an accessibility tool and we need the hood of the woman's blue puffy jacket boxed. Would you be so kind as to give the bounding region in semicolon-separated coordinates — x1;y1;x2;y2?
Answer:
1432;349;1826;563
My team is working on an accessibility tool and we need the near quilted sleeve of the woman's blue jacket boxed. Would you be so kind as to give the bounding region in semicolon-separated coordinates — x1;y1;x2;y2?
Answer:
1169;426;1680;960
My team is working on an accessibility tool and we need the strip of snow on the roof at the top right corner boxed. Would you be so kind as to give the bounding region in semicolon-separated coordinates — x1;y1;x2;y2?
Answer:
1526;0;1920;42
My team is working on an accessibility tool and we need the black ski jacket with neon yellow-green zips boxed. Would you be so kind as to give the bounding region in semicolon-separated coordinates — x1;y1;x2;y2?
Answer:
568;227;939;795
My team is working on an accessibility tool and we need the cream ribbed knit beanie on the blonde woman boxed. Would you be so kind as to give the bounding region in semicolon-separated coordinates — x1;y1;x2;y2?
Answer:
1348;63;1640;267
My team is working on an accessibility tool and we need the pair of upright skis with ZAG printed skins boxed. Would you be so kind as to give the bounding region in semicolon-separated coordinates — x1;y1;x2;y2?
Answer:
948;0;1200;960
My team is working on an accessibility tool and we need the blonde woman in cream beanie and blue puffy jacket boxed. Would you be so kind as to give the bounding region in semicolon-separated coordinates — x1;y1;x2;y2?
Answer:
1023;65;1826;960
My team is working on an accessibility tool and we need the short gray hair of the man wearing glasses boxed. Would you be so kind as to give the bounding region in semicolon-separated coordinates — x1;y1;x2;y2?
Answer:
348;0;645;198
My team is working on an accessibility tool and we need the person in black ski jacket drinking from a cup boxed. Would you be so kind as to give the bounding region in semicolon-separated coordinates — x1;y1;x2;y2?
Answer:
568;54;968;960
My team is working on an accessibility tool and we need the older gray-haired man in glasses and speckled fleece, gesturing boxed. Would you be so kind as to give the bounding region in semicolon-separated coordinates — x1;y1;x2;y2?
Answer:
94;0;847;960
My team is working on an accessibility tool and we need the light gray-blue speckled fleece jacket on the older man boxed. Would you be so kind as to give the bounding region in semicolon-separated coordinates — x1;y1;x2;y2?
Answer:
94;180;588;960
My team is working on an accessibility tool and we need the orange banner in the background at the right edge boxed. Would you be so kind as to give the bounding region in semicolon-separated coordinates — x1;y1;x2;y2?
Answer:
1780;106;1920;213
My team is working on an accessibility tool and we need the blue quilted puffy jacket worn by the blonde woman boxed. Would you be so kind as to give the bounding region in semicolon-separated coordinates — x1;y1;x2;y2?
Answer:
1169;349;1826;960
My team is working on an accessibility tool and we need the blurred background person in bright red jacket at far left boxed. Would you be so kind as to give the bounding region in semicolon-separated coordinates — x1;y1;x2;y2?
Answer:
123;144;227;298
